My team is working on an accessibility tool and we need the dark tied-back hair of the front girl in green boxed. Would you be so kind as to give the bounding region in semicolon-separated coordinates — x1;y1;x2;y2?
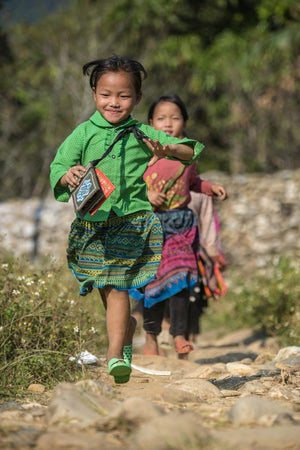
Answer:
82;55;147;94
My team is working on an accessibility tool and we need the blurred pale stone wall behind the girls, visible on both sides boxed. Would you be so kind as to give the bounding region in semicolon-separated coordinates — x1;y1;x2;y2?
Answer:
0;169;300;272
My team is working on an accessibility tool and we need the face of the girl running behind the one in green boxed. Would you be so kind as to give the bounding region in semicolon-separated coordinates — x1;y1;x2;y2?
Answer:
149;101;186;138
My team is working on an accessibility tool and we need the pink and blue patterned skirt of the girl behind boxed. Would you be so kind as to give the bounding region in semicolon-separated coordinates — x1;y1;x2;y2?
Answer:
129;208;199;308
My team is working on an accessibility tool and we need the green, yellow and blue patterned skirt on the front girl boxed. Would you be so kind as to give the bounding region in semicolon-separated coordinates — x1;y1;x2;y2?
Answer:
67;211;163;295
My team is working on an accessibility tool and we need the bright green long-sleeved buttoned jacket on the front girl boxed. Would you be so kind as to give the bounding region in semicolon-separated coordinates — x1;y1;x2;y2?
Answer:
50;111;204;222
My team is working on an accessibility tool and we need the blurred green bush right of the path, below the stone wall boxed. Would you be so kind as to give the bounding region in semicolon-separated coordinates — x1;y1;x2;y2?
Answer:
204;257;300;346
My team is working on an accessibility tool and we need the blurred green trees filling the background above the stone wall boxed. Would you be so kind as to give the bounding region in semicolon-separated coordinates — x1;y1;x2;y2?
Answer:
0;0;300;200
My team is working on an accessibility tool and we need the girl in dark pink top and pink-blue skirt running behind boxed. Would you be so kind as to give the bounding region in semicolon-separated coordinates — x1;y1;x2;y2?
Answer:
130;95;227;358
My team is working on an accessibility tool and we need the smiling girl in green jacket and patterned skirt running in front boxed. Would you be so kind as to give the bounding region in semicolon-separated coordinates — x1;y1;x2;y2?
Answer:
50;56;203;383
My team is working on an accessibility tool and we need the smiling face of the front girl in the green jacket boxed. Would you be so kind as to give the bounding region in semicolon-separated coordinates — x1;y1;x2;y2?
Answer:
93;72;142;127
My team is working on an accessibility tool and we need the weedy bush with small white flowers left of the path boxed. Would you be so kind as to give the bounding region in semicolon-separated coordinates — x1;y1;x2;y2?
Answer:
0;251;106;389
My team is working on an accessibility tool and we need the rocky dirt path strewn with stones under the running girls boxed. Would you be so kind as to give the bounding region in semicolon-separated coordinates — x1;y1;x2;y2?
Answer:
0;330;300;450
